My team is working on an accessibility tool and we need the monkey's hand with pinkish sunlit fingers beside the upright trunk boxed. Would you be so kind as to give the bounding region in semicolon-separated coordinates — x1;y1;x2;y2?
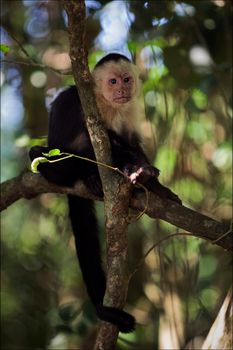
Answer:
124;165;159;184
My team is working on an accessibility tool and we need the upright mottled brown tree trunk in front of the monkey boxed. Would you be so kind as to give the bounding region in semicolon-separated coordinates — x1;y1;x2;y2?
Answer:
63;0;131;350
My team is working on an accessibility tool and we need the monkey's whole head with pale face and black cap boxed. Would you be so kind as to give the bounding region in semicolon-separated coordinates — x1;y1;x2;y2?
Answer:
93;54;139;109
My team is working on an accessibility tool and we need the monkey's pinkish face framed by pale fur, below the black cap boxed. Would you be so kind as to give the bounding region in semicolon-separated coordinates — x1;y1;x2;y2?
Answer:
95;62;139;108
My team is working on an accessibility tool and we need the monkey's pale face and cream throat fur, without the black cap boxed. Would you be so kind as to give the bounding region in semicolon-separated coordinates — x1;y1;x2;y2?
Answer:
92;60;143;134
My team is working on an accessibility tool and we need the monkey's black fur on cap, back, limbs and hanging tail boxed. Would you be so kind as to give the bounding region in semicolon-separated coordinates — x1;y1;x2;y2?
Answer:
29;54;180;332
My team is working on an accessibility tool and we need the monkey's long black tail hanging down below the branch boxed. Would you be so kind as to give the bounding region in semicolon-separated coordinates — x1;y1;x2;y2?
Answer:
68;195;135;333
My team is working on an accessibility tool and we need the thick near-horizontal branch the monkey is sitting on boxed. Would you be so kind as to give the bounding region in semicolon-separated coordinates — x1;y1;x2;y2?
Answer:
0;172;233;250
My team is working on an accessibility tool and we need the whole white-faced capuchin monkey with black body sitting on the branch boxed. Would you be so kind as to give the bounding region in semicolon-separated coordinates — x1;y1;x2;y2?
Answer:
29;53;181;333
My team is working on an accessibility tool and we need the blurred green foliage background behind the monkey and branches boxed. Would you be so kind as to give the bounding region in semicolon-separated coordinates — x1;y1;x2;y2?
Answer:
1;0;232;350
